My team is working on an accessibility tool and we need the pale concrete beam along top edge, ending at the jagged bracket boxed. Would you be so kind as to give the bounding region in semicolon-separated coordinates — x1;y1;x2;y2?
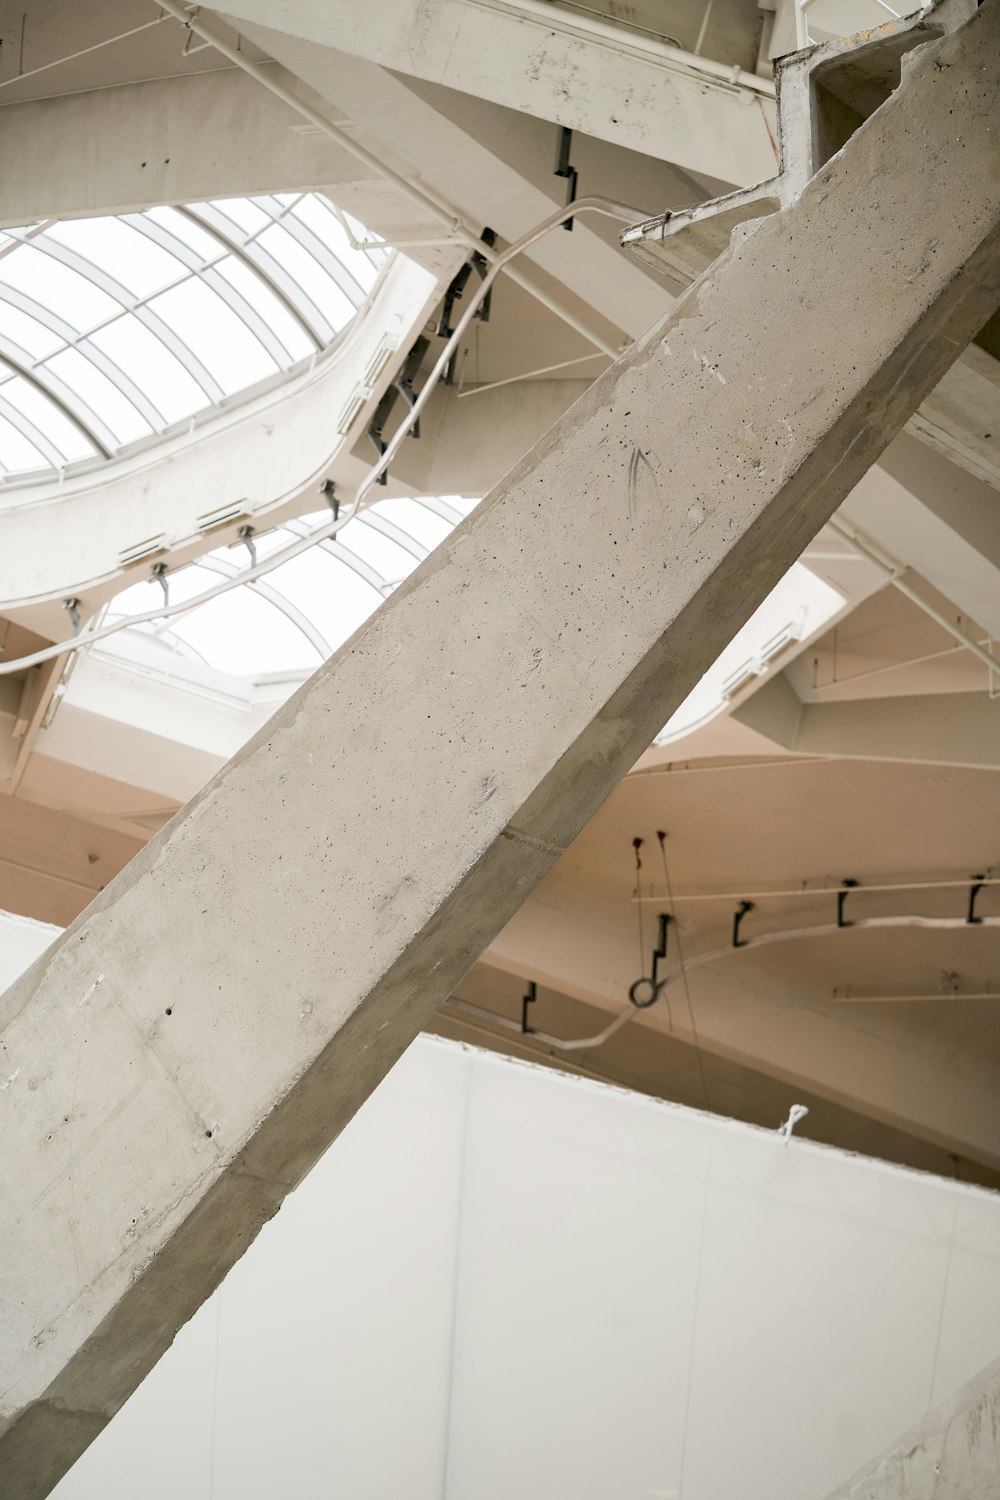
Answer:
220;0;775;186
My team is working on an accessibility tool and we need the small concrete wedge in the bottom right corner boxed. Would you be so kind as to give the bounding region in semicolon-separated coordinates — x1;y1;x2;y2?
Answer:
829;1359;1000;1500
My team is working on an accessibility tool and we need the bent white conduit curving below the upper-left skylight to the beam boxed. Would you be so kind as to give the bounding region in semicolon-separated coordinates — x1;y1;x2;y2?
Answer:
0;197;643;677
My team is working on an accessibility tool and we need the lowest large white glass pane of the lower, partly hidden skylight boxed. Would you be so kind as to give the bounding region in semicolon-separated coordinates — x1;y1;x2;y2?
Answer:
171;588;319;677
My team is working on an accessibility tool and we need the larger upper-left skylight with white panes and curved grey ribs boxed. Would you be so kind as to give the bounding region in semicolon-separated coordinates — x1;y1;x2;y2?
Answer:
0;194;390;483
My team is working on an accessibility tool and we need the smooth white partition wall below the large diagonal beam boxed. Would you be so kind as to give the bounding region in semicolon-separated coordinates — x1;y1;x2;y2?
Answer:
27;1038;1000;1500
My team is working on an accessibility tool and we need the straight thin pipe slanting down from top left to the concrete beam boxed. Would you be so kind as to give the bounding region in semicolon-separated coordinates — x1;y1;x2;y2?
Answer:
159;0;626;359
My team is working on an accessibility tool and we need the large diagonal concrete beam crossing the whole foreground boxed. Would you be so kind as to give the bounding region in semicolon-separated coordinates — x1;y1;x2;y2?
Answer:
0;0;1000;1500
